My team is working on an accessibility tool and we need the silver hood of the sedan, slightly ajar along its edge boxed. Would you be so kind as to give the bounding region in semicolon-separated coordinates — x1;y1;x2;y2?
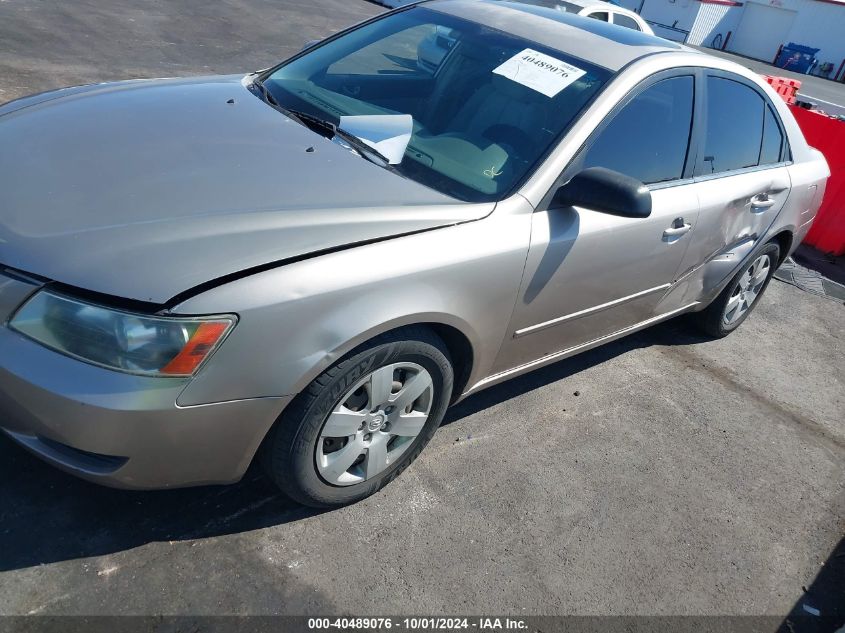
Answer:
0;77;493;303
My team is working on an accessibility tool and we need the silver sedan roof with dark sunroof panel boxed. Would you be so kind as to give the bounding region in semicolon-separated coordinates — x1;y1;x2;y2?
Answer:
422;0;690;72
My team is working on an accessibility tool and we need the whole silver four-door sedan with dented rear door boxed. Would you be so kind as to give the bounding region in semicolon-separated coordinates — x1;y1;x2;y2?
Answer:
0;0;829;506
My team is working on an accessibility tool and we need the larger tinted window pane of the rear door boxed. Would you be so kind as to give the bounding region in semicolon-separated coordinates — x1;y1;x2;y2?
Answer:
695;77;765;175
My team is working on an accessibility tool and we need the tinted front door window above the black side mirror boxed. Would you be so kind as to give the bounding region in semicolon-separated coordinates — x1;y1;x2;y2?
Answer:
580;76;695;184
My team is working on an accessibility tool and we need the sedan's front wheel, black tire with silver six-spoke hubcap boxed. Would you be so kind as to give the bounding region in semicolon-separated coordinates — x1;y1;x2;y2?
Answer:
261;327;454;508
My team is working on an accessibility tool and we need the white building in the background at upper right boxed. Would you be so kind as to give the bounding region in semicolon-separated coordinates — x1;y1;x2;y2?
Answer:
617;0;845;80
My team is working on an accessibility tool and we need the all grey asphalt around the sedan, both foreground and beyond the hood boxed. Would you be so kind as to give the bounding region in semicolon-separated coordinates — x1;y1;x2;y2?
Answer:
0;0;845;616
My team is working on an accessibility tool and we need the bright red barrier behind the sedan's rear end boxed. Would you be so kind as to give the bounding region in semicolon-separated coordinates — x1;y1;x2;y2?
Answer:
790;106;845;255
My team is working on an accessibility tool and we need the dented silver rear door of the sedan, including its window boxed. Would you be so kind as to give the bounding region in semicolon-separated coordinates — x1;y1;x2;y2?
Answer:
684;70;791;282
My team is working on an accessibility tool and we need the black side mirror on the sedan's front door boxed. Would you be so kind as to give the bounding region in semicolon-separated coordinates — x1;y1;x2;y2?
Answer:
553;167;651;218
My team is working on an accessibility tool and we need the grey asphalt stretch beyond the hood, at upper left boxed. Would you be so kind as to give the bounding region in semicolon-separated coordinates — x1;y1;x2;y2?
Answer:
0;0;385;102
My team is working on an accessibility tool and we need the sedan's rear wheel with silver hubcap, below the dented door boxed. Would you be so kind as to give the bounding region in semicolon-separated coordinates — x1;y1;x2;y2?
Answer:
691;242;780;338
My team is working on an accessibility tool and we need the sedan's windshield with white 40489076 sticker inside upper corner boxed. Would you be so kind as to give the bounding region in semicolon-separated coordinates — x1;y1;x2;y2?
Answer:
264;7;611;202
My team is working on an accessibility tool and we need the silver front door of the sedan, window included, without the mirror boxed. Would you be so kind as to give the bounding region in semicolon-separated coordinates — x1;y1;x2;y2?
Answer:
494;70;699;373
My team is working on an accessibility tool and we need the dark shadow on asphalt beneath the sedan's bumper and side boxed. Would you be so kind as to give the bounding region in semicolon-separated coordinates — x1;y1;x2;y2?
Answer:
0;322;704;571
